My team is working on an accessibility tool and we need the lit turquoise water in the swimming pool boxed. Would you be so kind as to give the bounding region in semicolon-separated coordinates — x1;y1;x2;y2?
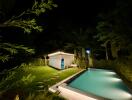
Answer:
68;69;132;100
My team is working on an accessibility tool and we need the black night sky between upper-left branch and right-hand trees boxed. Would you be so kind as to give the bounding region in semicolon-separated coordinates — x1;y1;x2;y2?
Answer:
48;0;115;26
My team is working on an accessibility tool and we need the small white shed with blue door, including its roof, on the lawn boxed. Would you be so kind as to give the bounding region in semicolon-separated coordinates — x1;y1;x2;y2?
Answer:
48;51;74;69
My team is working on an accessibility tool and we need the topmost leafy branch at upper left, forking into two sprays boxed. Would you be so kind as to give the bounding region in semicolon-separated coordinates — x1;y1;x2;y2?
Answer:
0;0;57;33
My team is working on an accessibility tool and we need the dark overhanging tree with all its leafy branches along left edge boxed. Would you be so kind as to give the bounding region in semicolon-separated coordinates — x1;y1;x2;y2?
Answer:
0;0;57;66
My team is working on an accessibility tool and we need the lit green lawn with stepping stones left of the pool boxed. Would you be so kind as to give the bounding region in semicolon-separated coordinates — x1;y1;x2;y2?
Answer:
0;66;80;100
